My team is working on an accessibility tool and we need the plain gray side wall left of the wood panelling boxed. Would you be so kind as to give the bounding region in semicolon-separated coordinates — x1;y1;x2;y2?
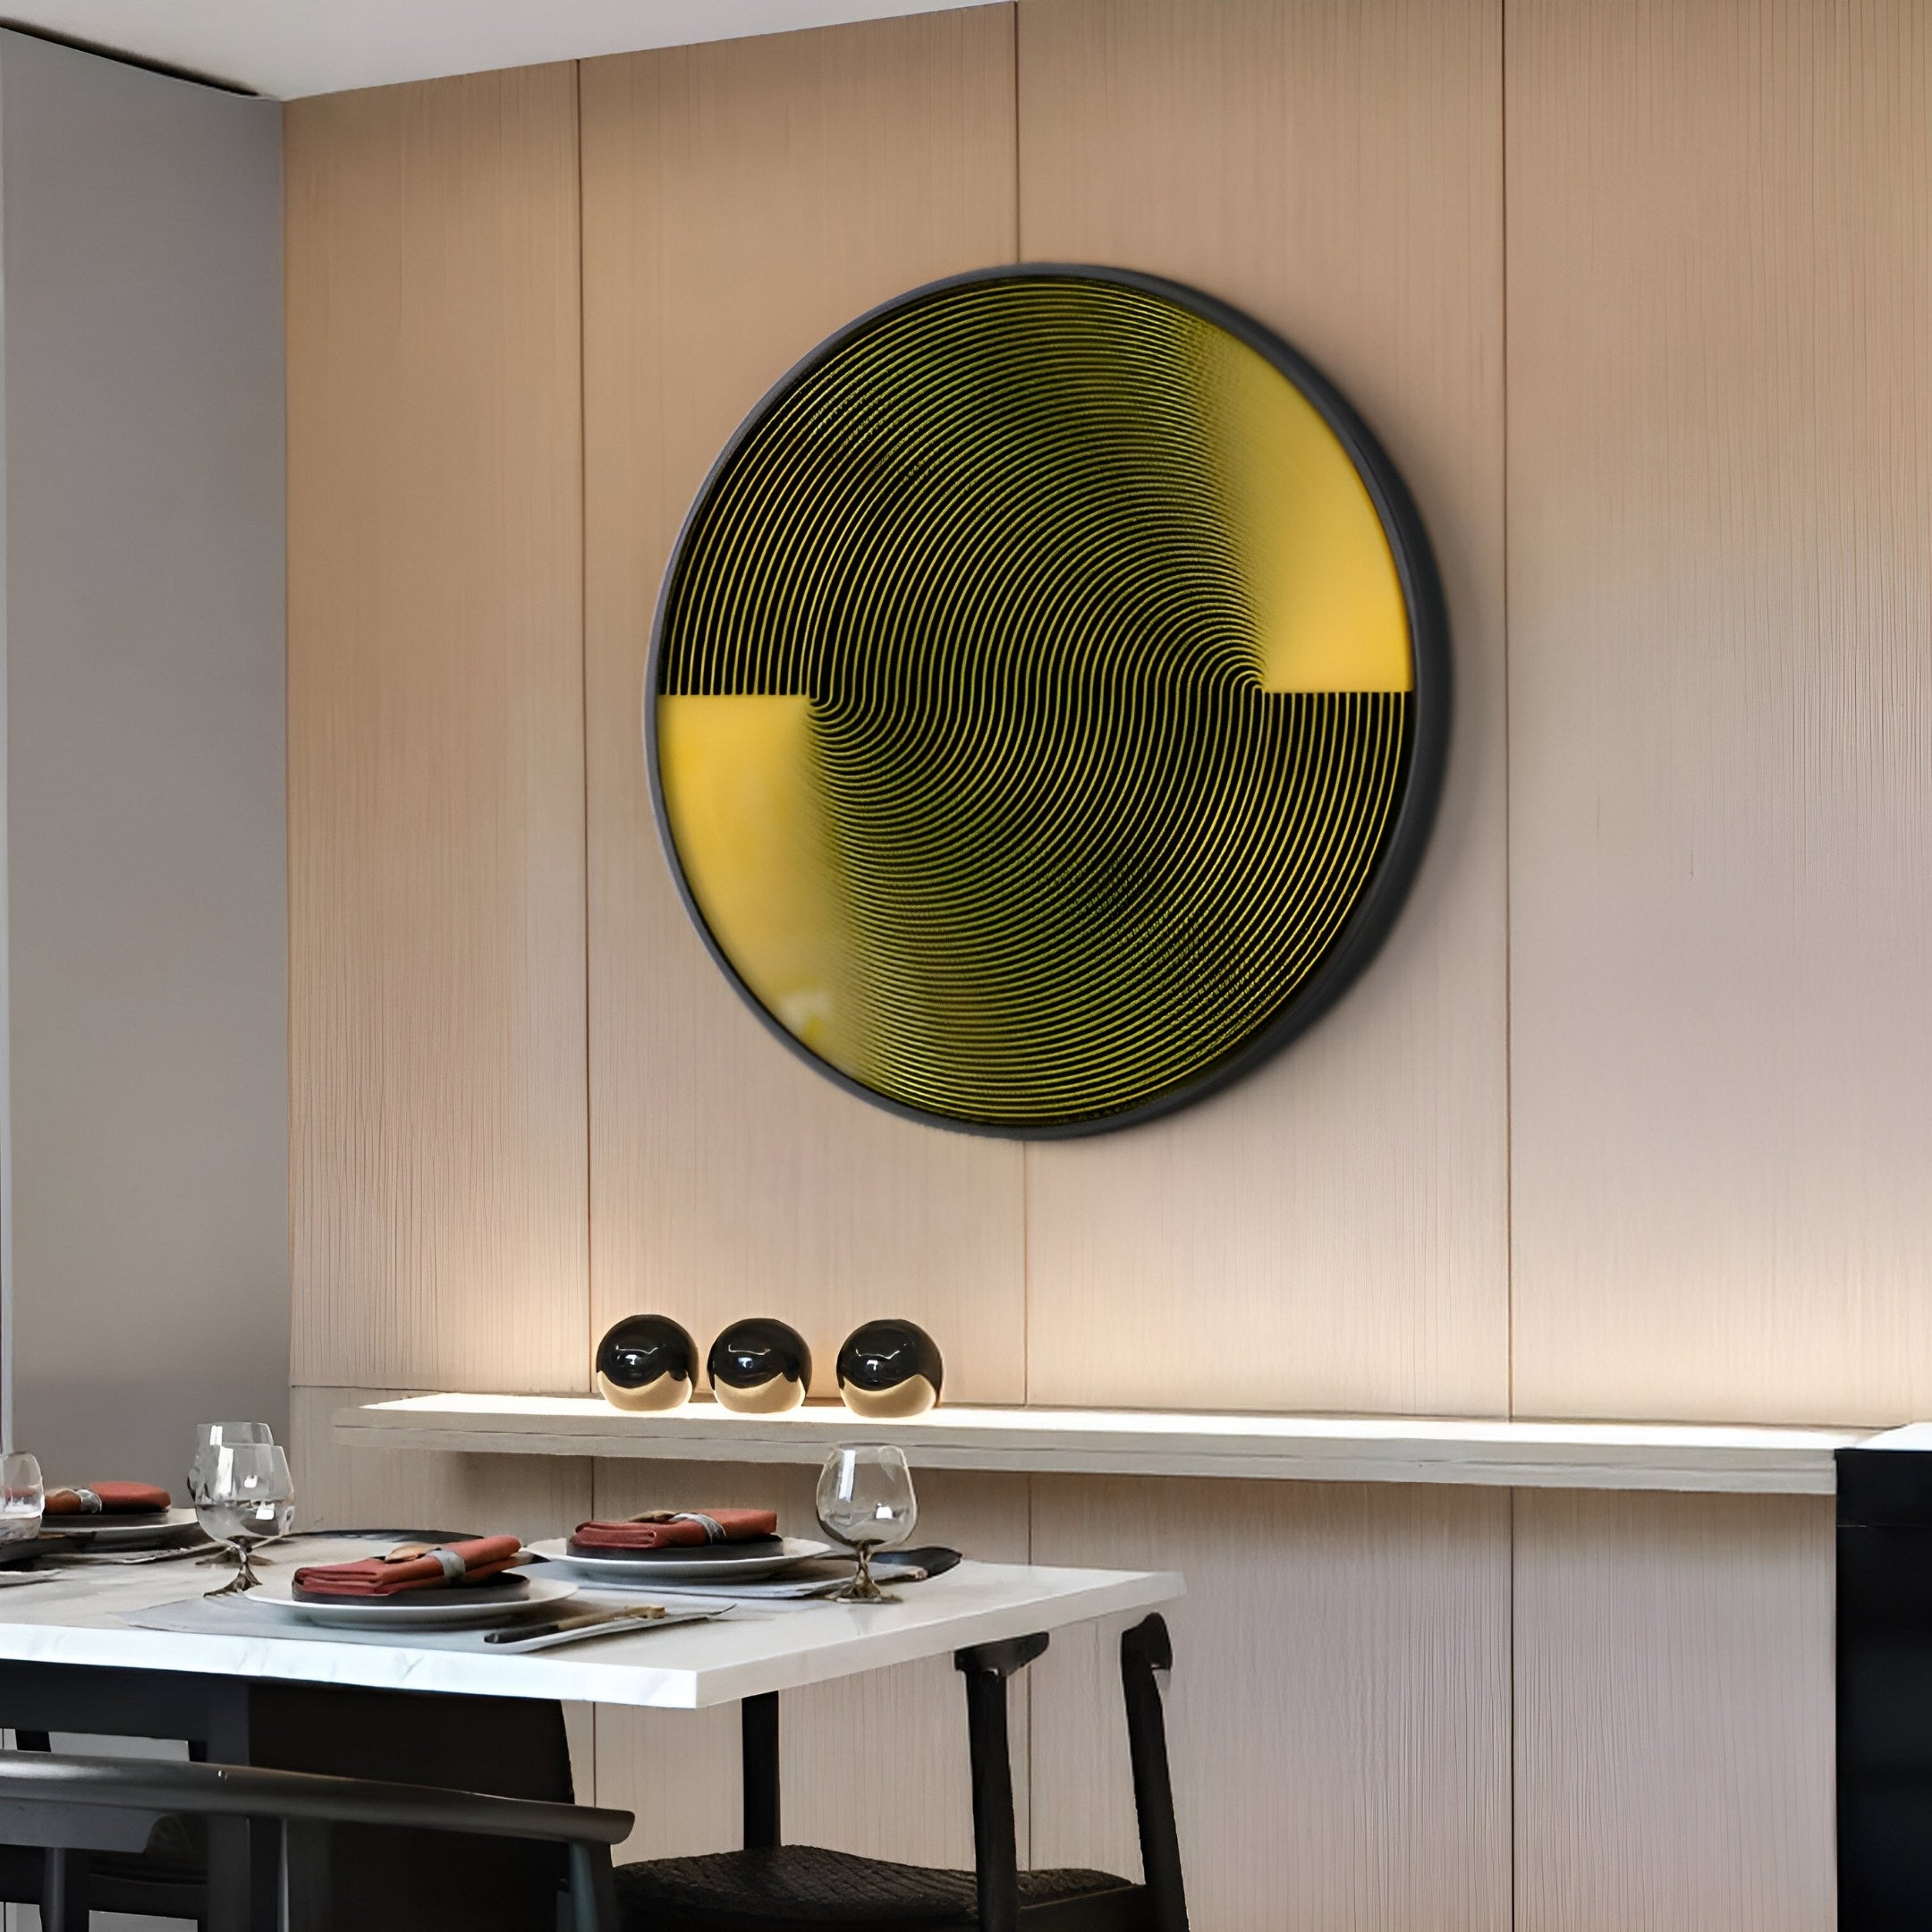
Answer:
0;33;288;1487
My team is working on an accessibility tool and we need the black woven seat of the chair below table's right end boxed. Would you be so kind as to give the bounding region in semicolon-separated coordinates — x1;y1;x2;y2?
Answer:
616;1845;1142;1932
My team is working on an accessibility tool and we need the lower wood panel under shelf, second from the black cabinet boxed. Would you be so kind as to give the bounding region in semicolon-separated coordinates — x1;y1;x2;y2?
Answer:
1030;1476;1511;1932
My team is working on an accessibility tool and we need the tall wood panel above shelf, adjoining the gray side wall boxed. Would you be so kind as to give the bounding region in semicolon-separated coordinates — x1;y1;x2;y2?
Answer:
286;65;589;1389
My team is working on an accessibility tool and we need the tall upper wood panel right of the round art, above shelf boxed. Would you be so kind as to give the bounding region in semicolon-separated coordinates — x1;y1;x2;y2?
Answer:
1509;0;1932;1422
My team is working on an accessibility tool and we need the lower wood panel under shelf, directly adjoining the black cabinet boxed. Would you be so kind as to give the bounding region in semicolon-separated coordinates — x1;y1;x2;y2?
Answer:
1514;1489;1835;1932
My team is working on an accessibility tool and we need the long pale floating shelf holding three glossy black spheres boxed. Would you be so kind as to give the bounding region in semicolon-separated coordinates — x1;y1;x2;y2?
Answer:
335;1395;1870;1496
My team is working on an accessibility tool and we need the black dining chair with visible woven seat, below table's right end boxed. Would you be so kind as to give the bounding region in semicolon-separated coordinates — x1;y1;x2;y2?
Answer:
616;1615;1188;1932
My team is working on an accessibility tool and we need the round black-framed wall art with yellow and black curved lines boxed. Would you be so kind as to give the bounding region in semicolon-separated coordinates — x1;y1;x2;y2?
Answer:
645;267;1449;1136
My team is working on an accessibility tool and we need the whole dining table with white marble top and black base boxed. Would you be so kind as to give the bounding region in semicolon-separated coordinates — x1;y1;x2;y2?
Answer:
0;1534;1184;1932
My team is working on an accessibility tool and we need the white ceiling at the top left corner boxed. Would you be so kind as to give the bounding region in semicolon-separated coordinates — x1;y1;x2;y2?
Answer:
0;0;976;100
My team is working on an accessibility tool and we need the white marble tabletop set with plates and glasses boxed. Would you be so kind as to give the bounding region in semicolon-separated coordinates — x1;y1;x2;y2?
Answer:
0;1538;1182;1710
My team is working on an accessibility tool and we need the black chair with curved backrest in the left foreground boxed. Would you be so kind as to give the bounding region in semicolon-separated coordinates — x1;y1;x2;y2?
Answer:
0;1752;633;1932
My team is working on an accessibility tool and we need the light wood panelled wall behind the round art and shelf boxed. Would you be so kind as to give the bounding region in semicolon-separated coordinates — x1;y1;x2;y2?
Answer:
288;0;1932;1932
